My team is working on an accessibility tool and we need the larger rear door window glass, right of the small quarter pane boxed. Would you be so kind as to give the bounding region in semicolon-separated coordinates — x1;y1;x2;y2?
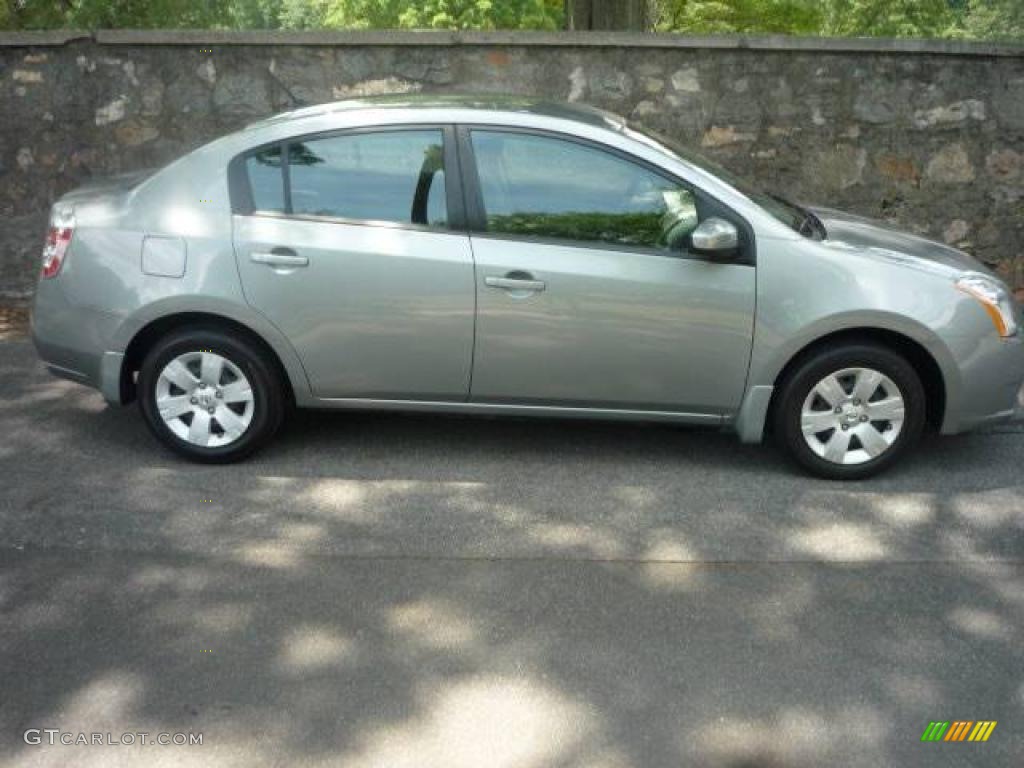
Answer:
288;129;447;226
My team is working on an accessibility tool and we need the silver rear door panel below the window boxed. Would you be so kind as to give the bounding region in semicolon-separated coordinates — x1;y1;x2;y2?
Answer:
236;216;474;400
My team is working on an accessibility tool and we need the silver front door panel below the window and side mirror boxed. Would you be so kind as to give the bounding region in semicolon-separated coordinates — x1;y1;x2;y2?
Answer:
472;237;755;416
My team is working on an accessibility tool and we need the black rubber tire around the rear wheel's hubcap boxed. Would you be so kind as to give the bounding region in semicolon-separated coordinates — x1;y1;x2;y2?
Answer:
137;327;286;464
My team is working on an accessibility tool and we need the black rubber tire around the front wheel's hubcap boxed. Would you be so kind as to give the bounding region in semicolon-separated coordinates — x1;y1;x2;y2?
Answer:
772;342;926;480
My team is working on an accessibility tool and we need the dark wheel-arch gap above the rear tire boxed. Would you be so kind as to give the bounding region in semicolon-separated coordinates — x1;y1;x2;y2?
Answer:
119;307;310;404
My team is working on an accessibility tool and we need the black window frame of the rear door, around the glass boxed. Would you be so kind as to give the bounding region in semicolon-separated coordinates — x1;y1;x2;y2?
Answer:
227;123;467;232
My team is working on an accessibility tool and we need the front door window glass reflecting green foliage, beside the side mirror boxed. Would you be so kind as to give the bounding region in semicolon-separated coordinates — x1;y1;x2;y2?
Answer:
471;130;699;250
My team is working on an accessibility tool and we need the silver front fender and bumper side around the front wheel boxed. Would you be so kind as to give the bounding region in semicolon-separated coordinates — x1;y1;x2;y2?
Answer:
739;238;1024;439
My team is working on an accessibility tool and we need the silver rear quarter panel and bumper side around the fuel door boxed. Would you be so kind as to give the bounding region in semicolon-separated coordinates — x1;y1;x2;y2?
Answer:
33;150;314;406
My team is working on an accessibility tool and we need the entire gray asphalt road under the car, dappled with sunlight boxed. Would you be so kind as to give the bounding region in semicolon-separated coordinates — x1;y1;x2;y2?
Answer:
0;340;1024;768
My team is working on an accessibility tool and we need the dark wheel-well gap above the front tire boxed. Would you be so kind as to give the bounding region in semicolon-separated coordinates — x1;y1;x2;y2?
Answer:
766;328;946;429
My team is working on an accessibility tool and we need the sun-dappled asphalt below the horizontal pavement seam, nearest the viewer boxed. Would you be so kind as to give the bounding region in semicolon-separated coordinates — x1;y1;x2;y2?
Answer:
0;552;1024;768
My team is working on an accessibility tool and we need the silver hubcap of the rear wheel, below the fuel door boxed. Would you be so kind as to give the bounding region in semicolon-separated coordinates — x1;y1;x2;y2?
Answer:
157;352;254;447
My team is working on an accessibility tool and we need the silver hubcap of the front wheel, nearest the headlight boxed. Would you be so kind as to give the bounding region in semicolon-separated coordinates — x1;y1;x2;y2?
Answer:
800;368;904;464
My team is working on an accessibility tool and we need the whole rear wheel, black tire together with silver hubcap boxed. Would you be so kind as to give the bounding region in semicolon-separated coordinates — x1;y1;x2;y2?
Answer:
138;328;284;463
